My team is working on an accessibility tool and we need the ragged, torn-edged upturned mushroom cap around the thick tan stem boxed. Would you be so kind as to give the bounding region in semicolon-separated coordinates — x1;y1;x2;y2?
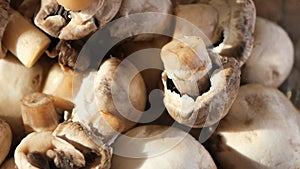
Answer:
162;52;240;128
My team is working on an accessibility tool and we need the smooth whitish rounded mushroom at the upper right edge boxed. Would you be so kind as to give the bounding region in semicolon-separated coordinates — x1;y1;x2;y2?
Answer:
242;17;294;87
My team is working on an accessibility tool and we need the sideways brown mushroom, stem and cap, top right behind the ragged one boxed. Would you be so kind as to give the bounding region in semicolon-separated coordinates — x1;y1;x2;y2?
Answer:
174;0;256;66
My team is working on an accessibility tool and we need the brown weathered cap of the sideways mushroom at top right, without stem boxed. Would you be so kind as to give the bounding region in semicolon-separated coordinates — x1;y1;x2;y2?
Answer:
207;0;256;66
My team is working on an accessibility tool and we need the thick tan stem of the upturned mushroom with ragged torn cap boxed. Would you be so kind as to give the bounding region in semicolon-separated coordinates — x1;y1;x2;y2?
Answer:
161;36;212;96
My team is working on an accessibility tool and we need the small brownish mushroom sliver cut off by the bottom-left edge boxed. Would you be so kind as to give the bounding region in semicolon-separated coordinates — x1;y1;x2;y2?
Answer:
0;119;12;165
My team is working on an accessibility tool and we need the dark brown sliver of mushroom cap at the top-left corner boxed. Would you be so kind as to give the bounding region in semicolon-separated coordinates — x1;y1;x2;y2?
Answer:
0;0;10;58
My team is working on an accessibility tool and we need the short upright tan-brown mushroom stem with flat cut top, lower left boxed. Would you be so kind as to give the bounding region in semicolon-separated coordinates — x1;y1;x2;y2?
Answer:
21;93;59;133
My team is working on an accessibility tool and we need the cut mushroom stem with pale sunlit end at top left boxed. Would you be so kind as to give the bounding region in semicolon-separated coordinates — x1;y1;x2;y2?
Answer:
3;9;51;67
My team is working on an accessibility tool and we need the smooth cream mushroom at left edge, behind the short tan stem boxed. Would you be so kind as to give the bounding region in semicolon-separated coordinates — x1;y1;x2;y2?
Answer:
0;54;43;142
